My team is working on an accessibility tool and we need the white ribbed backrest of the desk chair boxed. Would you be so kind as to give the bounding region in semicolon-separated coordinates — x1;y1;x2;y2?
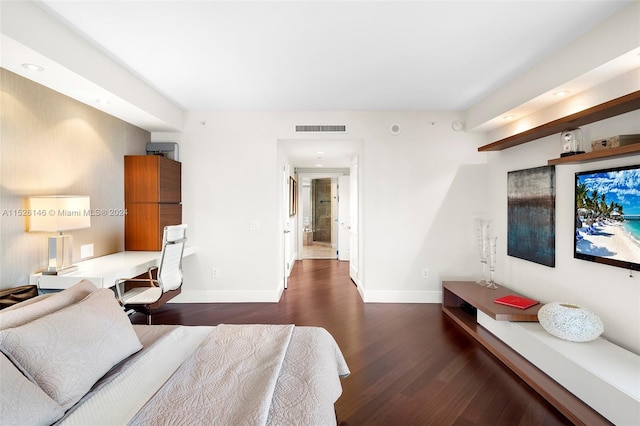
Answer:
158;224;187;293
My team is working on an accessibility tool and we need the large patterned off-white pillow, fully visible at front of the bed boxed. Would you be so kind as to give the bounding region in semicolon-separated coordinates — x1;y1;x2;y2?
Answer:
0;289;142;410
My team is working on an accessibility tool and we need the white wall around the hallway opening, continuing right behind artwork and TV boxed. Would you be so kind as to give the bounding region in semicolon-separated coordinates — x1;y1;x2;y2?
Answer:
164;101;640;352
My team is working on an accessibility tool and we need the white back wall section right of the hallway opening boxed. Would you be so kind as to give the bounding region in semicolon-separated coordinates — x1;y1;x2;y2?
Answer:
359;112;487;302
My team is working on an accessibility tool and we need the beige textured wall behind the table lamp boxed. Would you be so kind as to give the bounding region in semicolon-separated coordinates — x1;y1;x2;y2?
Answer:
0;69;150;288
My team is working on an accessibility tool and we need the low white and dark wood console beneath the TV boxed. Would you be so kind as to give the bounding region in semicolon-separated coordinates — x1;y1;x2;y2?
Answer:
442;281;640;426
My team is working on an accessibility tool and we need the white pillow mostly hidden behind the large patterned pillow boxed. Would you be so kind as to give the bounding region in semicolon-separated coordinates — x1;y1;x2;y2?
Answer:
0;280;97;330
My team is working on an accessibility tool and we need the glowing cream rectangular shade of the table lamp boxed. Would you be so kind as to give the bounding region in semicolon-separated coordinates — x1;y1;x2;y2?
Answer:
29;195;91;232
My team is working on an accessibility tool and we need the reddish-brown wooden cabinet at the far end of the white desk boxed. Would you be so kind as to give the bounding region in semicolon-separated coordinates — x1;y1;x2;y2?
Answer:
124;155;182;251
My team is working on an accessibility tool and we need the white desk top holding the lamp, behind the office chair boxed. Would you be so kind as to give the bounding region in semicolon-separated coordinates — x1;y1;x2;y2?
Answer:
29;246;196;290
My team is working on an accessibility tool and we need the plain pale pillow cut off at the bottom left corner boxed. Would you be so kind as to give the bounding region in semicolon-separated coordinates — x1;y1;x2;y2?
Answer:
0;354;64;426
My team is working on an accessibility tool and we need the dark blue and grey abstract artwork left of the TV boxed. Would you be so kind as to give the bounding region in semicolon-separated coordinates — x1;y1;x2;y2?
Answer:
507;166;556;267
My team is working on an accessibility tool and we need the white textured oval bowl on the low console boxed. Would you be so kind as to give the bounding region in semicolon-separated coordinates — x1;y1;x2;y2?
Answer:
538;302;604;342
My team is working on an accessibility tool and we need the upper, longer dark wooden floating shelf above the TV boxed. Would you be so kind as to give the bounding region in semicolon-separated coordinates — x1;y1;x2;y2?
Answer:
478;90;640;153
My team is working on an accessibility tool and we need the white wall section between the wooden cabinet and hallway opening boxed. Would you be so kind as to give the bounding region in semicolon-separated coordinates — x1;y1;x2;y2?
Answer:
164;112;283;301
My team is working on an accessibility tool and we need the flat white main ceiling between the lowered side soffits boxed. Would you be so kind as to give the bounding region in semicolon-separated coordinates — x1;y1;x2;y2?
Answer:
39;0;630;111
